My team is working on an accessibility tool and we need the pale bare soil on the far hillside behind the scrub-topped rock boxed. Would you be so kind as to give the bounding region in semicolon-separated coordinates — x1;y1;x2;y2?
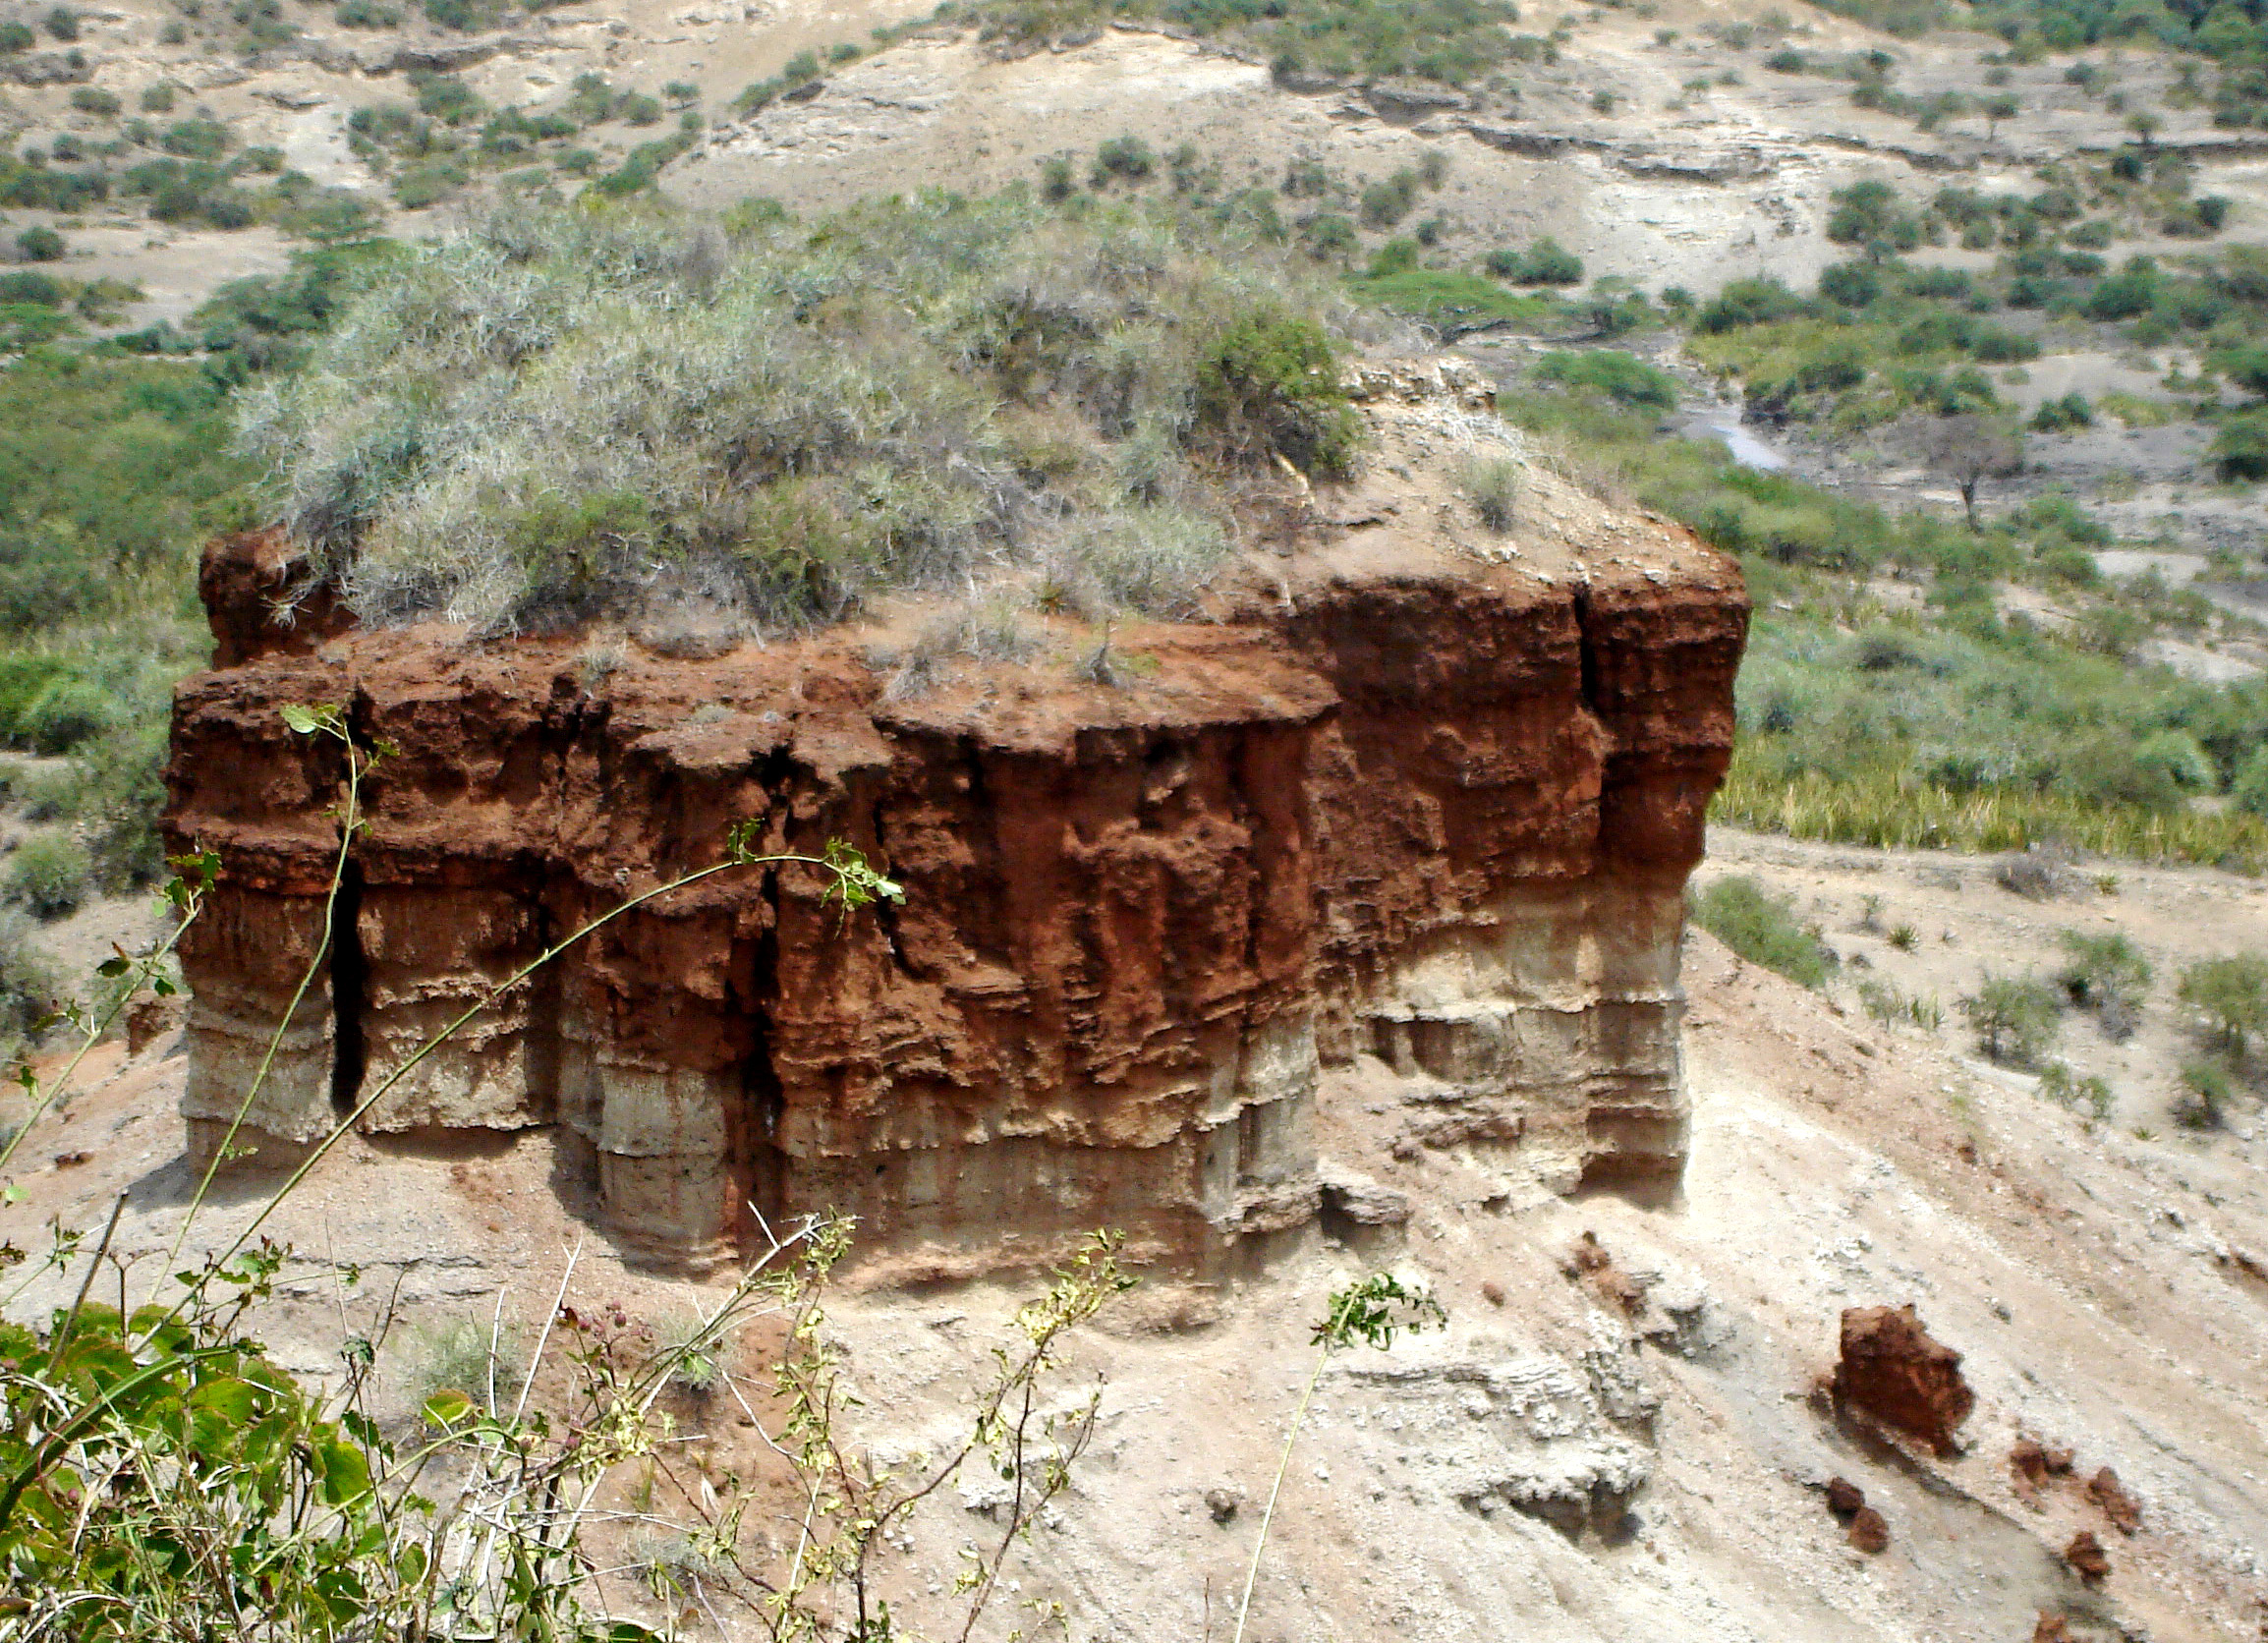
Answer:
0;0;2268;321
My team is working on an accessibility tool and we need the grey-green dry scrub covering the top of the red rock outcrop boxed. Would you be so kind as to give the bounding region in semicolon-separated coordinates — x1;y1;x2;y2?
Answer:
243;193;1354;631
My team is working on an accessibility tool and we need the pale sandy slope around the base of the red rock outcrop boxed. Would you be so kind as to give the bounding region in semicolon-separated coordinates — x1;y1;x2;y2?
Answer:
7;837;2268;1643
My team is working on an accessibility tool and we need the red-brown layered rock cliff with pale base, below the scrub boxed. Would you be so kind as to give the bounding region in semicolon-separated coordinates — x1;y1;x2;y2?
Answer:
168;524;1746;1274
